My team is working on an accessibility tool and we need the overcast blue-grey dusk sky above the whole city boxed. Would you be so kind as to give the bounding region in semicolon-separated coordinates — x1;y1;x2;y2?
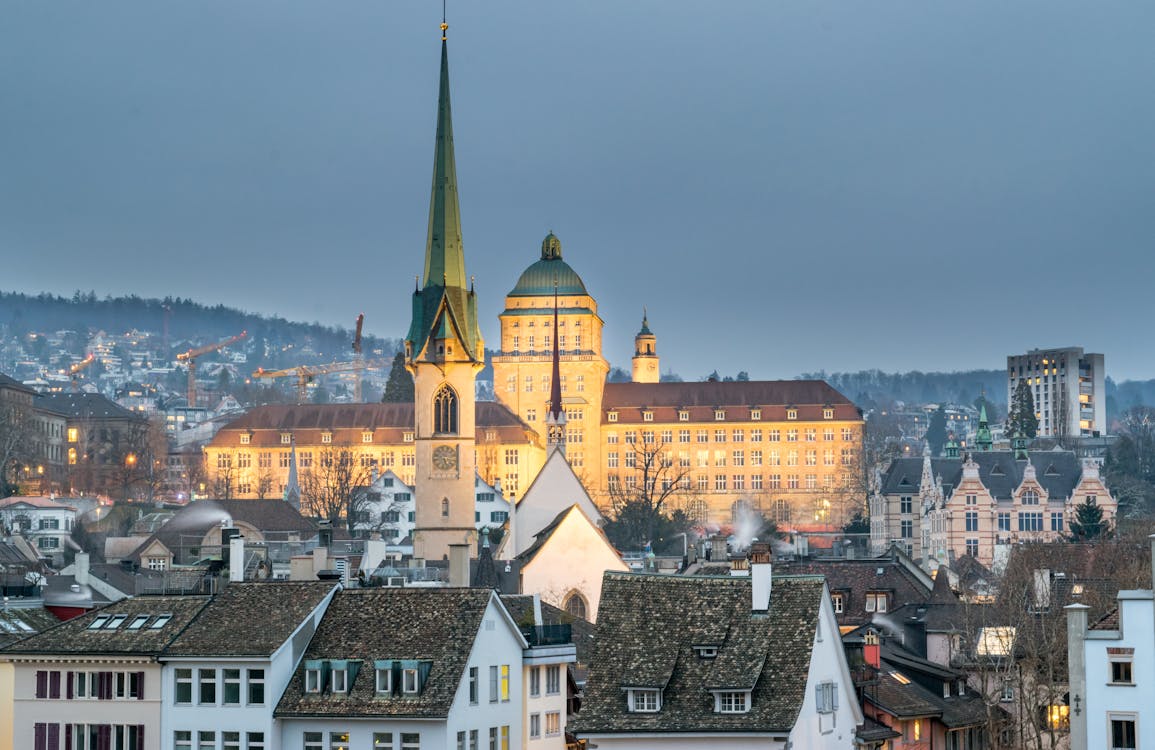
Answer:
0;0;1155;380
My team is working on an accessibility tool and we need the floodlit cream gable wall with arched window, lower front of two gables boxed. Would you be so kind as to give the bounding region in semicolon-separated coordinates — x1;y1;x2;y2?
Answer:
517;512;629;622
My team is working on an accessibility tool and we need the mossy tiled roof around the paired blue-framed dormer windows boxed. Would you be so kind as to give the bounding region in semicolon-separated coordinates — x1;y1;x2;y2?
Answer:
275;588;493;719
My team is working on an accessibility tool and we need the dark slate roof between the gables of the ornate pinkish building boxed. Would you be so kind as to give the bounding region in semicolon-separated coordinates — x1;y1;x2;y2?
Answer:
882;451;1082;500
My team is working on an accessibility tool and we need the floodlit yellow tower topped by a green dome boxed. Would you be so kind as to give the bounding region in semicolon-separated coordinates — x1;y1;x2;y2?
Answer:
493;232;610;483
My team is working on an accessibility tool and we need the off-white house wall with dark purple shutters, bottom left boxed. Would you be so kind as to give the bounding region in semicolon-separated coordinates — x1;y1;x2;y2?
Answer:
13;661;162;750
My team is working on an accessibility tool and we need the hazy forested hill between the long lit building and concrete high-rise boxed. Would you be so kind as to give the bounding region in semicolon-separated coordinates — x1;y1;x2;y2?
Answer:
799;370;1007;408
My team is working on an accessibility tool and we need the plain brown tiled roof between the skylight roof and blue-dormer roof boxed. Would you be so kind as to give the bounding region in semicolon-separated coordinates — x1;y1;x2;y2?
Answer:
165;581;335;656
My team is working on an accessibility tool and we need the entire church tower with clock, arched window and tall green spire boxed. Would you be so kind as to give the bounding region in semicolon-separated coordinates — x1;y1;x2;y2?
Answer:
405;23;485;559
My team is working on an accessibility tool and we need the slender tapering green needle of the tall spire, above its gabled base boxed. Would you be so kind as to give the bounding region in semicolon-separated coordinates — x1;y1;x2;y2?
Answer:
424;39;465;289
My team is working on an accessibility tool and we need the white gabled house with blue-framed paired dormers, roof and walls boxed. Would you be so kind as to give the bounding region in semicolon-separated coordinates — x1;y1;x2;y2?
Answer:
275;588;530;750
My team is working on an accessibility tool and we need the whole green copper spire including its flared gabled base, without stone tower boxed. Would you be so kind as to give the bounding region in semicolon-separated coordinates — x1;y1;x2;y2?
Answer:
405;34;484;362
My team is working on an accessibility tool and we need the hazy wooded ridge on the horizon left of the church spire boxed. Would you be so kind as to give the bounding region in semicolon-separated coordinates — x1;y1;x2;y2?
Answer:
0;291;400;364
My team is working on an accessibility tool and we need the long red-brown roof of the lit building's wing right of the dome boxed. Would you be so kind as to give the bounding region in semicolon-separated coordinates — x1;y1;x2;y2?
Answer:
602;380;862;423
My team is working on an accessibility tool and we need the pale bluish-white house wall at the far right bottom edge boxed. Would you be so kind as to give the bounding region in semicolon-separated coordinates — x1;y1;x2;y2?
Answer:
1083;592;1155;748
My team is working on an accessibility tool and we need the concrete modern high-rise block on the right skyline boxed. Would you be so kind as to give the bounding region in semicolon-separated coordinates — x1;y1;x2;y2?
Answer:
1007;347;1106;438
